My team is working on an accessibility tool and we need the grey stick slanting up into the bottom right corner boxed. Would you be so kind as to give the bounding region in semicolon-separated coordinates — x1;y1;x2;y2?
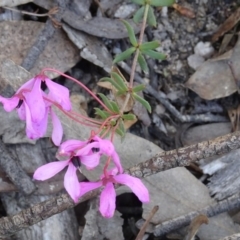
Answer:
154;193;240;236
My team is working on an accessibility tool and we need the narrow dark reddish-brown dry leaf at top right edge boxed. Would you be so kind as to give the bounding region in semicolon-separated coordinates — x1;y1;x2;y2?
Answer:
212;7;240;42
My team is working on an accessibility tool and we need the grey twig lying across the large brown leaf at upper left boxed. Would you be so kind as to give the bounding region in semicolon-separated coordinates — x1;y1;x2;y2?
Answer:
21;0;68;71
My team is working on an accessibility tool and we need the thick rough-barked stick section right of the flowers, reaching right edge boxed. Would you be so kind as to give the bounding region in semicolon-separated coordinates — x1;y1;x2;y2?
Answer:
126;132;240;178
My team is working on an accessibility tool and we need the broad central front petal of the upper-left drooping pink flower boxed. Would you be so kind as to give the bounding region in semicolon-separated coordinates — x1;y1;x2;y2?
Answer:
23;81;46;123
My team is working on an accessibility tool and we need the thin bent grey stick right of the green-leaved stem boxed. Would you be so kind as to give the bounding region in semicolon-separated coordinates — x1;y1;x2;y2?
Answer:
118;62;228;123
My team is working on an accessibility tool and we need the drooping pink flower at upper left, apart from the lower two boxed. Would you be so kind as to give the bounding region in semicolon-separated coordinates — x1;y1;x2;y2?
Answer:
0;75;71;145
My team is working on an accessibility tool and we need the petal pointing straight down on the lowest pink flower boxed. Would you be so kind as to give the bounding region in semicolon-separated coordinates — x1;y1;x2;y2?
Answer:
99;182;116;218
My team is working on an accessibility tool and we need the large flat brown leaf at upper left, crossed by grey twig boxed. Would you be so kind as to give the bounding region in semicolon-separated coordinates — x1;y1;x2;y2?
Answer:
0;21;80;77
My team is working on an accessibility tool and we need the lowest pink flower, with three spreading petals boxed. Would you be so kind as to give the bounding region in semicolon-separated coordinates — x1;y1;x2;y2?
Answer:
79;169;149;218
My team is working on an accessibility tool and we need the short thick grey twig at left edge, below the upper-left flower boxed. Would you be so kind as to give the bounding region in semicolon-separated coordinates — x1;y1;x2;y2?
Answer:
0;139;35;194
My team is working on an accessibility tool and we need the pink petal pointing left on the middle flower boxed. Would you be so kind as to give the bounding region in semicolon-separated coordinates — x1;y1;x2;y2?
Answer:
33;160;69;181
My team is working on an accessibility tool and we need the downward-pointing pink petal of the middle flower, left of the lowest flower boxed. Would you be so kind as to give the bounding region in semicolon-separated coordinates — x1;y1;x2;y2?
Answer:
64;162;80;203
